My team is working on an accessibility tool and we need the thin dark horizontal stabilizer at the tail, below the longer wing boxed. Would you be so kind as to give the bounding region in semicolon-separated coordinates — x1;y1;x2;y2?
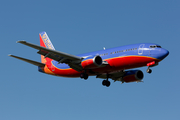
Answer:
8;55;45;67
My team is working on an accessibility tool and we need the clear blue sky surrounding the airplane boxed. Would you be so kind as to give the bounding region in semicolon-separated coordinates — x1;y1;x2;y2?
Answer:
0;0;180;120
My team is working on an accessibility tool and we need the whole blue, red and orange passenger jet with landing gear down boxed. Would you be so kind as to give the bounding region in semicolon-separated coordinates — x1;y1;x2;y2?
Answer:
9;31;169;87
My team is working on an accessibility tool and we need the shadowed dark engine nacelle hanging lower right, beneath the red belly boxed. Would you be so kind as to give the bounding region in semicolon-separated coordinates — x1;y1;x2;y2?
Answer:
123;70;144;83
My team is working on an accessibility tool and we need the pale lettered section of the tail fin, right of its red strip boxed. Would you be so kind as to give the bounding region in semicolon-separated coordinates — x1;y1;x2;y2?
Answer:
41;32;54;50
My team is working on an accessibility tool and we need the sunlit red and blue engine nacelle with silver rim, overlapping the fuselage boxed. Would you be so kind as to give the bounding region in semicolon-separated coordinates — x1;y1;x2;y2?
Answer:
81;56;103;69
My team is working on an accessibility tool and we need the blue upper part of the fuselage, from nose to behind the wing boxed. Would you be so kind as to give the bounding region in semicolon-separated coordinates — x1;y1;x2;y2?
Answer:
52;43;169;69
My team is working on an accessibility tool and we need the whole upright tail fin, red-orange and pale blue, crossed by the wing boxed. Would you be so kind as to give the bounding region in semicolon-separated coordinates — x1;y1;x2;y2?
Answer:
39;31;55;63
